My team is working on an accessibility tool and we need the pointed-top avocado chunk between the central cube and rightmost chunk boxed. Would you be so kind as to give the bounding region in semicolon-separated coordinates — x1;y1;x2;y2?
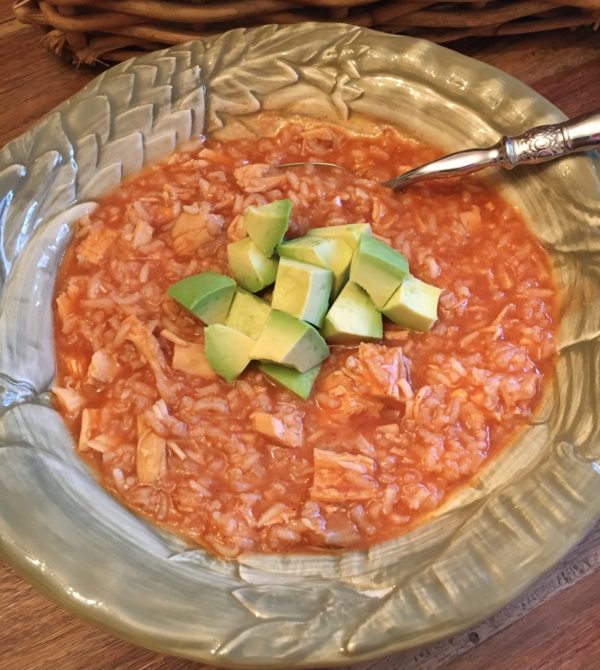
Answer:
321;282;383;344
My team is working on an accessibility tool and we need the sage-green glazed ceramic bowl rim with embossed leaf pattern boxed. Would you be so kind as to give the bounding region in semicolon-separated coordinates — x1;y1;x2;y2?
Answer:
0;23;600;668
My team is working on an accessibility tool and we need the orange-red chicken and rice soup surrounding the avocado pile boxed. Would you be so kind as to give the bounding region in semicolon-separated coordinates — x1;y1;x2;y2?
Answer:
54;117;556;557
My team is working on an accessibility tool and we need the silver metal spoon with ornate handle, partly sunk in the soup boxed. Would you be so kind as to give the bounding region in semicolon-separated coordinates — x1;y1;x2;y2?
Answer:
273;112;600;191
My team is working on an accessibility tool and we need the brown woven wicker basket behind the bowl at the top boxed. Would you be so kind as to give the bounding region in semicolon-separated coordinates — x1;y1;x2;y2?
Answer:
14;0;600;63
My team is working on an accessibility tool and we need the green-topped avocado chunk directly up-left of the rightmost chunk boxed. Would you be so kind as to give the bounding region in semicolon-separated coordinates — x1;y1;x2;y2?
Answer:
350;235;408;309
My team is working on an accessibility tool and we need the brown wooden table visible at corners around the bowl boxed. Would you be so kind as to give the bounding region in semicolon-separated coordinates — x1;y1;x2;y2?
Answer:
0;7;600;670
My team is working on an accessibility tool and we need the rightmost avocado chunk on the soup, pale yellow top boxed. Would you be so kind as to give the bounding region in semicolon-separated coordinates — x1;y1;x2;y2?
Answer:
383;275;442;331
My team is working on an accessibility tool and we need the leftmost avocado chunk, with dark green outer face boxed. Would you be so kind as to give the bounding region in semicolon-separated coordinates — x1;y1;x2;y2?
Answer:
167;272;236;324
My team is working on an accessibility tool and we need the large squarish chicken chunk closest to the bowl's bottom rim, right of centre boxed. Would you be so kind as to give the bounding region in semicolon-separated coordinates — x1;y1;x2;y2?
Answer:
310;448;377;502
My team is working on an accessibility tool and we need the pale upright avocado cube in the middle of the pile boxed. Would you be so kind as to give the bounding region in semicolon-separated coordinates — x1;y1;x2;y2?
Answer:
271;258;333;326
